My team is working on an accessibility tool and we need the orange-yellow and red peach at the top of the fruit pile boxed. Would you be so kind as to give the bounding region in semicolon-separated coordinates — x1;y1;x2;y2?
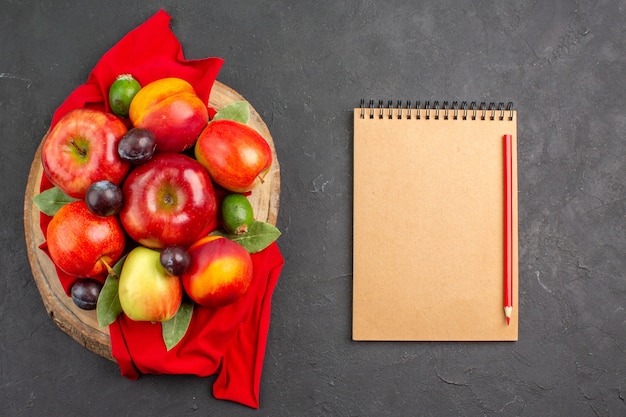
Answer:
129;77;209;152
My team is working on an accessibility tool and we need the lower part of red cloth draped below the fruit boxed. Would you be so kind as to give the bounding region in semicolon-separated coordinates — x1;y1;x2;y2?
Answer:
109;243;283;408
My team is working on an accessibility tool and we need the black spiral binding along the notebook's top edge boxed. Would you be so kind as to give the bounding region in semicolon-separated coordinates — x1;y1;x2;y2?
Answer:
360;99;513;120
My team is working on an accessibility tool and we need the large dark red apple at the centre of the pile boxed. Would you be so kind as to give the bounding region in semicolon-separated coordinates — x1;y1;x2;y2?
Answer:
120;152;217;249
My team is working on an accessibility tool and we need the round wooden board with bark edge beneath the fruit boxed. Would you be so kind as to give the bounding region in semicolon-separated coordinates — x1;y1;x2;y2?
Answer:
24;81;280;361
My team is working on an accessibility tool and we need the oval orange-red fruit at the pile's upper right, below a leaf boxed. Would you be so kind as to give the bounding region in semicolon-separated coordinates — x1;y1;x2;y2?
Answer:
194;119;272;193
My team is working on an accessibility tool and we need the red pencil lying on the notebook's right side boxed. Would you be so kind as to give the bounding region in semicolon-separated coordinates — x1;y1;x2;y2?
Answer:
503;135;513;325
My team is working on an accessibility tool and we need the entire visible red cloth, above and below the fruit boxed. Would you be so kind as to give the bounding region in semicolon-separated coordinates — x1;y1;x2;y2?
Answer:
40;10;284;408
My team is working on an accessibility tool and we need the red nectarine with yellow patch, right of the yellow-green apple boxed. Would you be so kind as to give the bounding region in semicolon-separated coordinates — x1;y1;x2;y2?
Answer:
181;236;253;308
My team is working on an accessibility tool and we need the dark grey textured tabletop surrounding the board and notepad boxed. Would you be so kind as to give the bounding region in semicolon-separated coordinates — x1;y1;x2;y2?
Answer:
0;0;626;417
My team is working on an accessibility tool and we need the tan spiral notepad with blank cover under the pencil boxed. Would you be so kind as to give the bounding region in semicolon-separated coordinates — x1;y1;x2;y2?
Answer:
352;102;519;341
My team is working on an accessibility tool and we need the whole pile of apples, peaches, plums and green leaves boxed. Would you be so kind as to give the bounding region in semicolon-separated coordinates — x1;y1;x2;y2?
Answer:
34;74;280;349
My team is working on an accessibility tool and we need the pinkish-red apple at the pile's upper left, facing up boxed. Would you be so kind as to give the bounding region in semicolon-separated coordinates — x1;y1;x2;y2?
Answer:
41;108;130;198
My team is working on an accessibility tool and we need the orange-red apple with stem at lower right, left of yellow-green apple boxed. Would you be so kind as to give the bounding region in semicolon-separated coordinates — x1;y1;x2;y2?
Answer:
46;200;126;277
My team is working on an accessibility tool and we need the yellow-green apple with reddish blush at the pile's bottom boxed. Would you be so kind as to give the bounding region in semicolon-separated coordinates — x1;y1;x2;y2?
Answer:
118;246;183;322
